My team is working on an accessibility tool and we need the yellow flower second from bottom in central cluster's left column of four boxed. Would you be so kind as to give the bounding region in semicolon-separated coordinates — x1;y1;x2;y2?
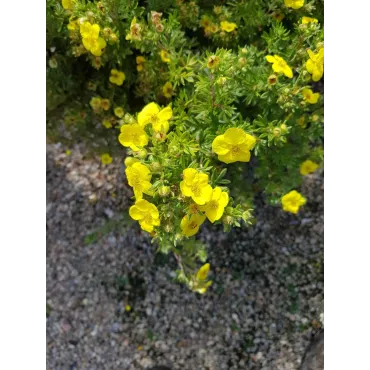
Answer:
125;162;153;200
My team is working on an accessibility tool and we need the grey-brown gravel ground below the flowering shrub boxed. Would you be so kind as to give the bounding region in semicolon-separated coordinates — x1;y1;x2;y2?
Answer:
46;145;324;370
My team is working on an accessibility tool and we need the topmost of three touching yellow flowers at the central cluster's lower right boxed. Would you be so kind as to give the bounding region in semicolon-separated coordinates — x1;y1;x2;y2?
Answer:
180;168;212;205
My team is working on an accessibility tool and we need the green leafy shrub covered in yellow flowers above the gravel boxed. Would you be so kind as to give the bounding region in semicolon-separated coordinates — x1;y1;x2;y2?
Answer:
47;0;324;293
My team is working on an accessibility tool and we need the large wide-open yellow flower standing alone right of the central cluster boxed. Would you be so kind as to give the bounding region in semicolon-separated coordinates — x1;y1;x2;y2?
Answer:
212;128;256;163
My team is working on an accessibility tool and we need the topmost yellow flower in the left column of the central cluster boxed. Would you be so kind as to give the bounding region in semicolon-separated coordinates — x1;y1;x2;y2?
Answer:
137;103;172;133
